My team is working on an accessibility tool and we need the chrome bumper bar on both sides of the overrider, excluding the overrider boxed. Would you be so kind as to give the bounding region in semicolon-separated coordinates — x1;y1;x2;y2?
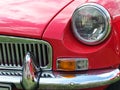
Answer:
0;69;120;90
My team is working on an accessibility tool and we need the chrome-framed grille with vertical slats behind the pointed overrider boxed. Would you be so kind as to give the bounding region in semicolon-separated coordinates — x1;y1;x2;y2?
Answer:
0;36;52;70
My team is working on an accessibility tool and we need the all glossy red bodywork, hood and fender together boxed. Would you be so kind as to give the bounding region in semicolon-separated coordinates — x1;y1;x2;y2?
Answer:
0;0;120;90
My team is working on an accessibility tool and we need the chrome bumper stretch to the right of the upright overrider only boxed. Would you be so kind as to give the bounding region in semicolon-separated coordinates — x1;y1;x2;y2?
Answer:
40;69;120;90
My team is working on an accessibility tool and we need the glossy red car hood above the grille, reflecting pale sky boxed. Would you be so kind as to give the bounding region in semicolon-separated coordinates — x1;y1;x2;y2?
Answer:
0;0;72;38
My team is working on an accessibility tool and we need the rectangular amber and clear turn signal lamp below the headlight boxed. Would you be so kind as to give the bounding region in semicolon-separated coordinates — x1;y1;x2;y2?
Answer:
57;58;88;71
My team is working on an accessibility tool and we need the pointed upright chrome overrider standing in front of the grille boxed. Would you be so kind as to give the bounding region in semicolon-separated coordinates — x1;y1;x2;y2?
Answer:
21;52;42;90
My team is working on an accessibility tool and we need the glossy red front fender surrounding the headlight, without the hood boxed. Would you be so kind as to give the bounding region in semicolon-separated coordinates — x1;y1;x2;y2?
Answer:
43;1;120;70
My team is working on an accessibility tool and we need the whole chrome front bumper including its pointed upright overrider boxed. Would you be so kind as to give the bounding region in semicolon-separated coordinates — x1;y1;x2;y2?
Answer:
0;54;120;90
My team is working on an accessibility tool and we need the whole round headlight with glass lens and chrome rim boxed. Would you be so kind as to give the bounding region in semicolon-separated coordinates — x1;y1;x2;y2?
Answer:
72;3;111;45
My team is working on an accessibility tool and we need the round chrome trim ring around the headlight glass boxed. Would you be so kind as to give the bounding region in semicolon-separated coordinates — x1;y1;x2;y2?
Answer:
72;3;111;45
